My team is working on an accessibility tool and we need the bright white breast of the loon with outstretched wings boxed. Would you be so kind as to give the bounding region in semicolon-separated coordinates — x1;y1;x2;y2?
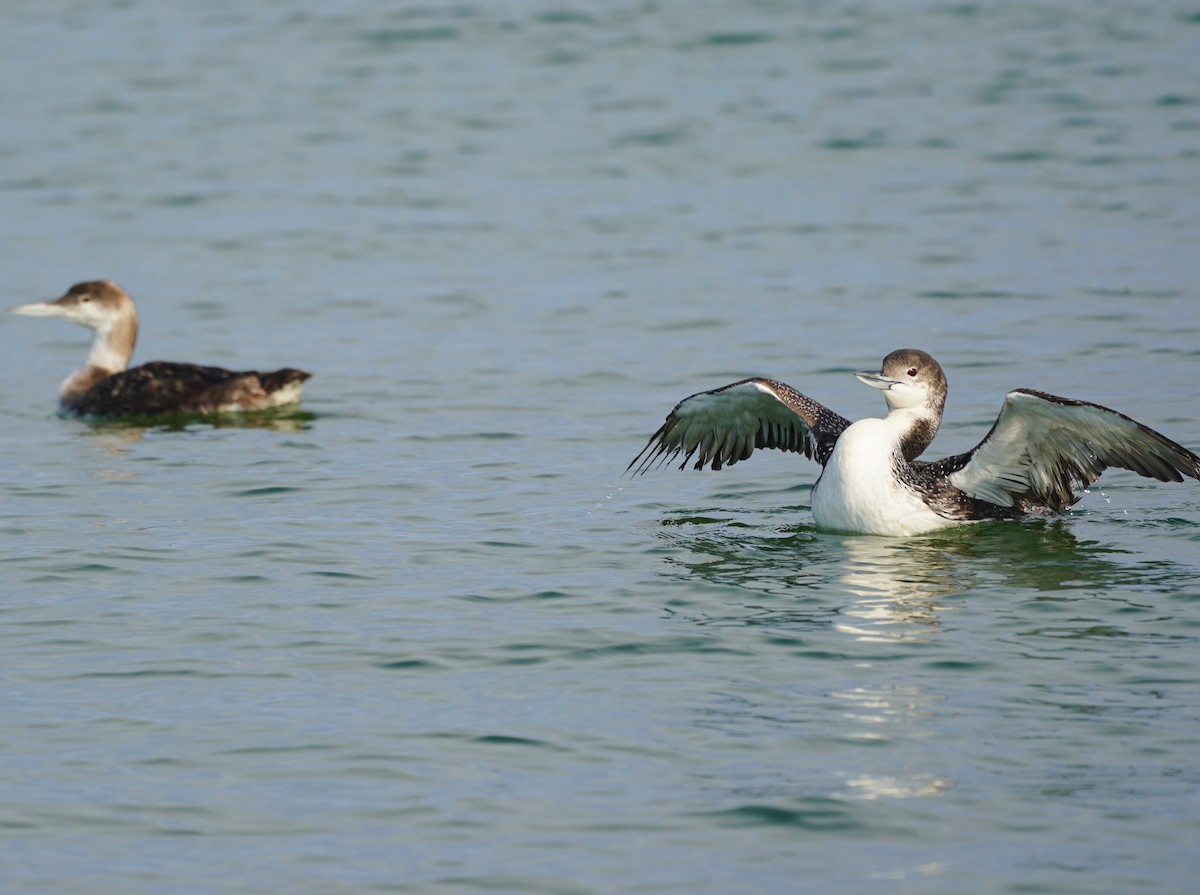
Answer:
812;413;955;536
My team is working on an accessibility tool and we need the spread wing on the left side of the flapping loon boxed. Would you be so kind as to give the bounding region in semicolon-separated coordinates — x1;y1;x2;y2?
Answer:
625;379;850;473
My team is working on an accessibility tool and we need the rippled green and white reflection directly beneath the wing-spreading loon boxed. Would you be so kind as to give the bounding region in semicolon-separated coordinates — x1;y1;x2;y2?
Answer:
659;506;1188;641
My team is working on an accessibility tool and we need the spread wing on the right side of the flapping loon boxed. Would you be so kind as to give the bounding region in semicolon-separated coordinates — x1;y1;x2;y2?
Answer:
930;389;1200;512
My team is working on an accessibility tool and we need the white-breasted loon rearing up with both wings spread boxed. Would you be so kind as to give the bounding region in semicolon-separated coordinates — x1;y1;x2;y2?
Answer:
625;348;1200;536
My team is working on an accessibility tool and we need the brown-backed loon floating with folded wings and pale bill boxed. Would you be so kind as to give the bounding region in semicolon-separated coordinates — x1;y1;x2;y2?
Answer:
8;280;312;418
